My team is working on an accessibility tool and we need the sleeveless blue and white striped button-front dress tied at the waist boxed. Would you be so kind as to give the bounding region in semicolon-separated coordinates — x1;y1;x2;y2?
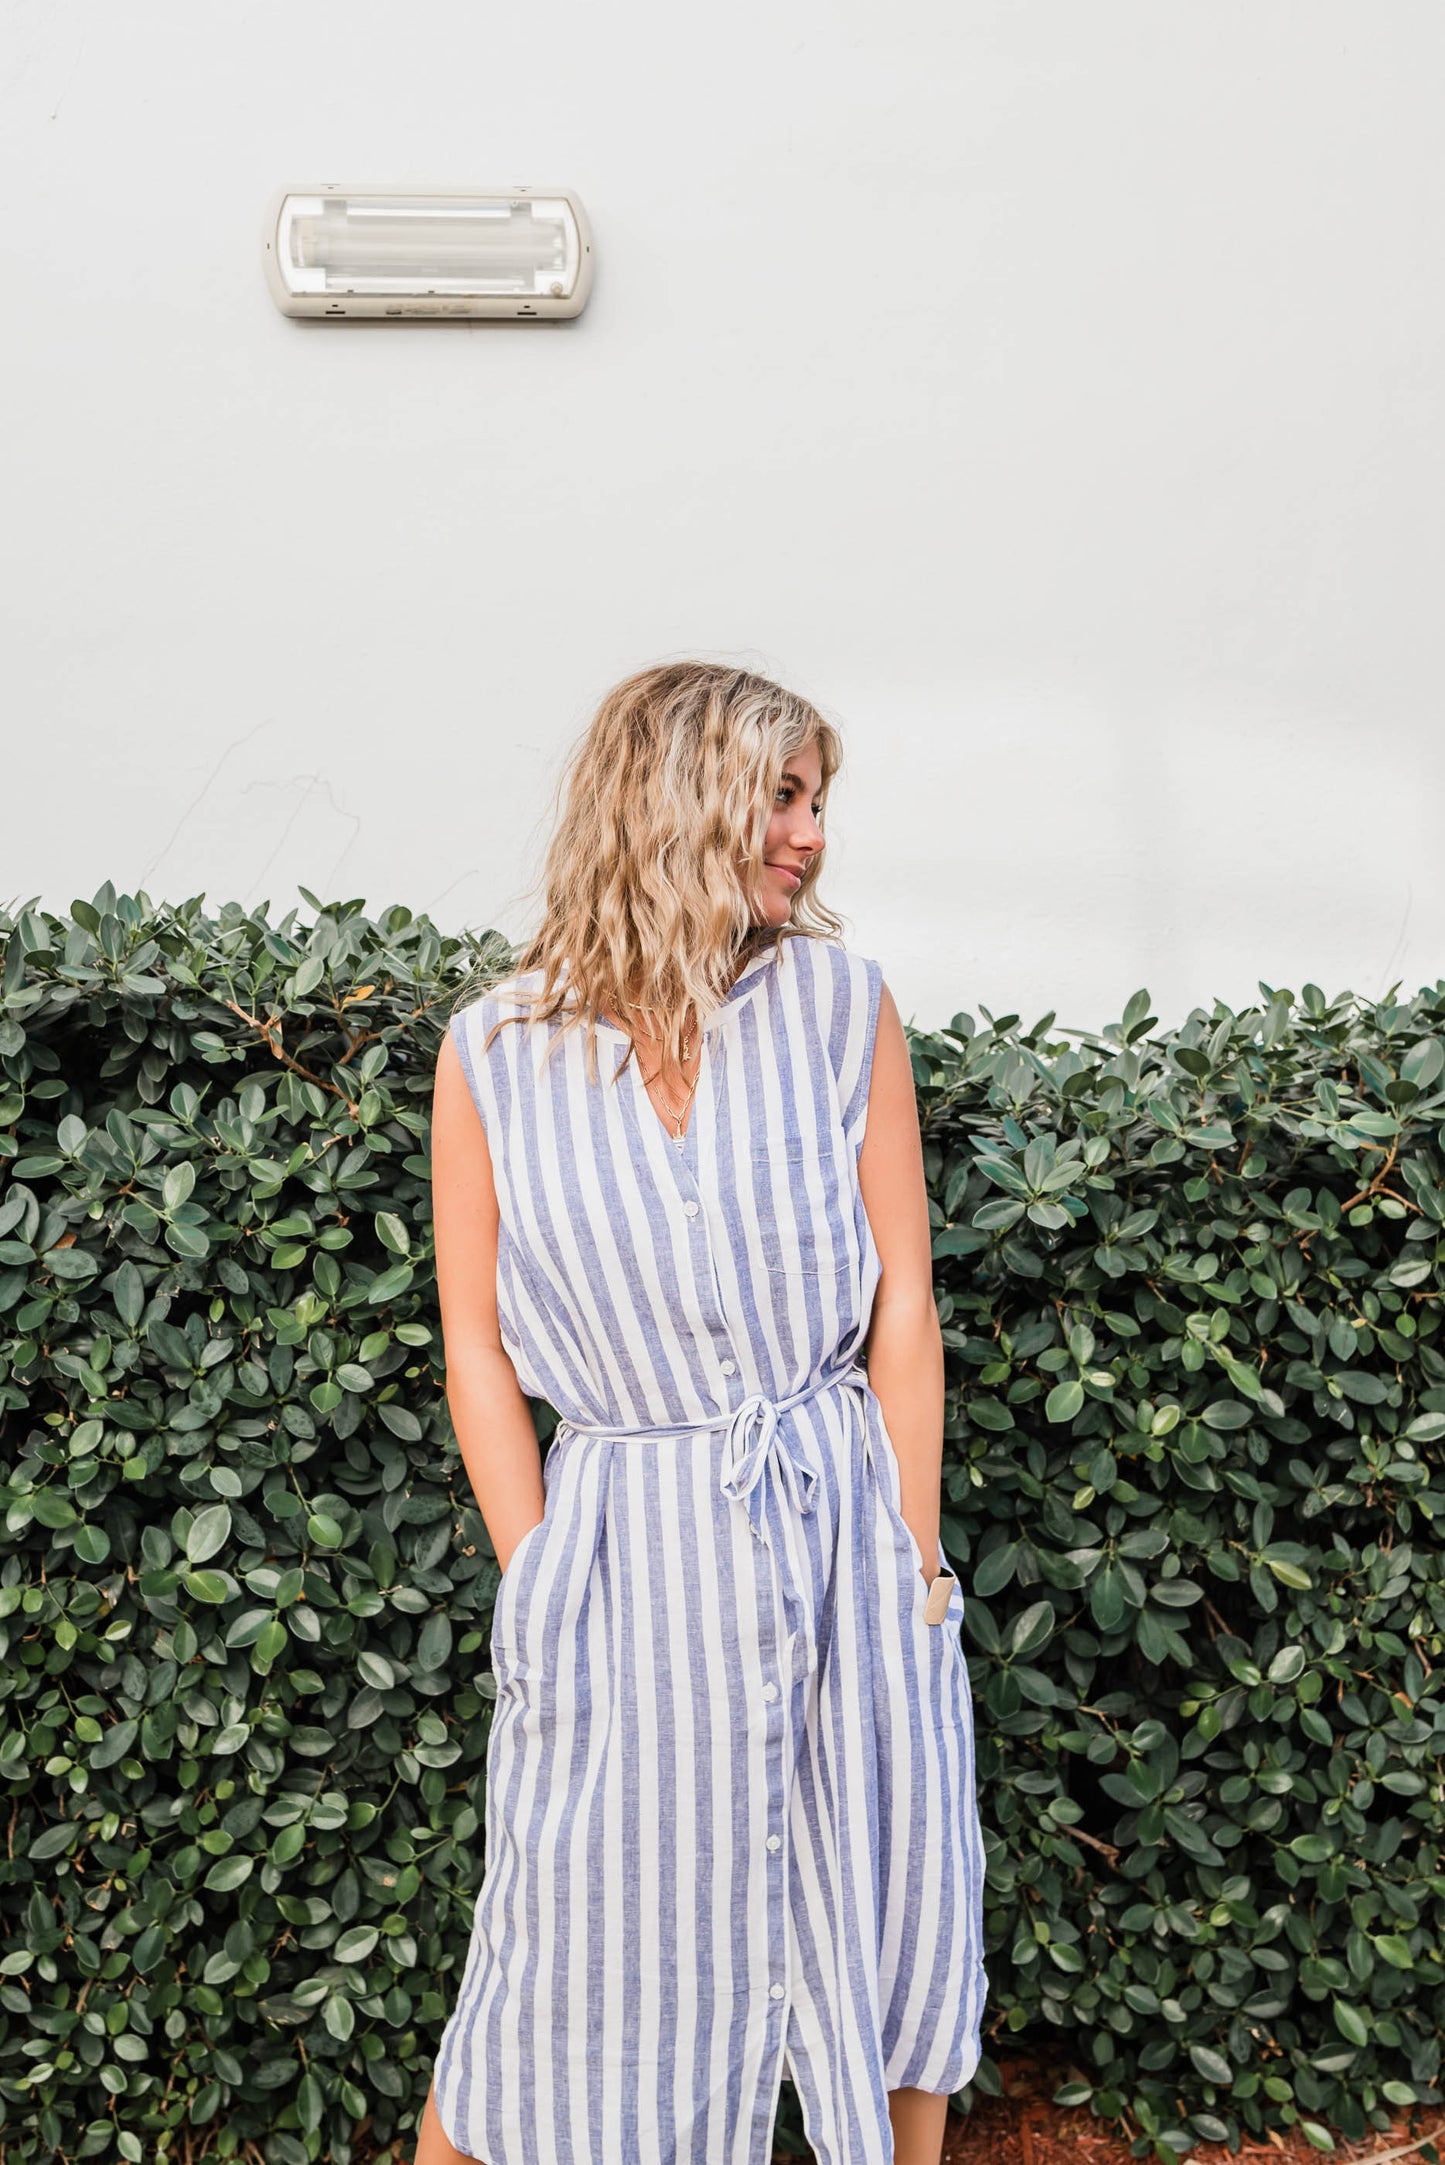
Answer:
433;933;988;2165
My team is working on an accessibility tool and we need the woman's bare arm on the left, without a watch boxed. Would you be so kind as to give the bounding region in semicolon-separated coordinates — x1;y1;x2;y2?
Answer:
431;1031;546;1570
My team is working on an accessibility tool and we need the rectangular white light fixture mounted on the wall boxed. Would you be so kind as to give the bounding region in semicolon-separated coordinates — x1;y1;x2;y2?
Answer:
264;182;591;323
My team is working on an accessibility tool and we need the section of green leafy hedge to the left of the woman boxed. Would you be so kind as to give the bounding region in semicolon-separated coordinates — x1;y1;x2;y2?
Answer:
0;890;507;2165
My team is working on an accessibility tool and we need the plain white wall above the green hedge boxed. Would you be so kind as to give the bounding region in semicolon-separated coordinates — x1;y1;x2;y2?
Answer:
0;0;1445;1026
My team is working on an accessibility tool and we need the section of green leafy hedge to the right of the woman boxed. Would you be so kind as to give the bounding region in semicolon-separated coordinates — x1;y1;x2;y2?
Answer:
914;983;1445;2156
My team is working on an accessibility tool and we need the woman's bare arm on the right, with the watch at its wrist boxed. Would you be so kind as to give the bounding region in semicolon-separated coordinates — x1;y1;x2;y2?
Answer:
858;985;942;1583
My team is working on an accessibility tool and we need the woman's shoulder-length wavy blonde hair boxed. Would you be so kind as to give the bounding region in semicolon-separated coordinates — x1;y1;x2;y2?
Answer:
463;662;843;1080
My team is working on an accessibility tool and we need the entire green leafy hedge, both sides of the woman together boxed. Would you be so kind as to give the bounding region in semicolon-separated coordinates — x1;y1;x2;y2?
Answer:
0;888;1445;2165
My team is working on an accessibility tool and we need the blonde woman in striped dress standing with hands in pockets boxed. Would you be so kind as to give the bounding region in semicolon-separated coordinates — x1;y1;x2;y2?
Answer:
416;662;988;2165
